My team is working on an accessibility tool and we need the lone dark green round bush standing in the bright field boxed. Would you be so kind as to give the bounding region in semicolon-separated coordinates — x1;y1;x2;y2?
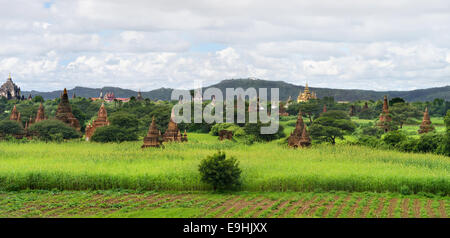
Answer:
199;151;242;191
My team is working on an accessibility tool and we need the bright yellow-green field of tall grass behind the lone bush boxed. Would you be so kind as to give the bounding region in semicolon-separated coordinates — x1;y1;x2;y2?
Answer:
0;133;450;194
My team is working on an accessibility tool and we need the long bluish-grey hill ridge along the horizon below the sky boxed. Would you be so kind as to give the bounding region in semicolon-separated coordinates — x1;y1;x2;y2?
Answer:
22;79;450;102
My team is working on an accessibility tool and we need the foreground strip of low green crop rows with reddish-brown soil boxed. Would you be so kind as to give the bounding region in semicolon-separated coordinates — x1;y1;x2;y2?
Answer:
0;191;450;218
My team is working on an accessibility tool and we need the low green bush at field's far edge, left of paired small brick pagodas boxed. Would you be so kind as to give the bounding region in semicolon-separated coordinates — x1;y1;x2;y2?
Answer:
91;125;138;143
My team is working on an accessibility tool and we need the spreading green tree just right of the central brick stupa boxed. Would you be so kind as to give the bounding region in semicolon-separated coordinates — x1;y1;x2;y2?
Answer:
309;111;356;145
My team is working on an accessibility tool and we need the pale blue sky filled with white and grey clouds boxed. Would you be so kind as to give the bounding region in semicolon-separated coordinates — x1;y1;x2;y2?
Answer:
0;0;450;91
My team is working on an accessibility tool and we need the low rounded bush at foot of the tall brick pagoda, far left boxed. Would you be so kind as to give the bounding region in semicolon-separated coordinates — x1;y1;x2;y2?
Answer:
28;120;80;141
